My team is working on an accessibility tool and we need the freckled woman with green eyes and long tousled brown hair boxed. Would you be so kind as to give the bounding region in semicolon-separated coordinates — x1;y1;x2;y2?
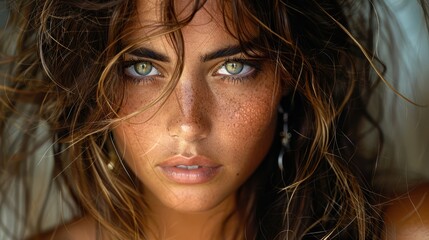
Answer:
1;0;426;239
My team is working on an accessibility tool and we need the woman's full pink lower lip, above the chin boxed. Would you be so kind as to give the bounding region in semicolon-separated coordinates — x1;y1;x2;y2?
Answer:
161;167;220;184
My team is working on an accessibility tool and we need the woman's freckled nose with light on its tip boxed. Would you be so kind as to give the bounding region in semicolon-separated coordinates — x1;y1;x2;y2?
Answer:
167;77;211;142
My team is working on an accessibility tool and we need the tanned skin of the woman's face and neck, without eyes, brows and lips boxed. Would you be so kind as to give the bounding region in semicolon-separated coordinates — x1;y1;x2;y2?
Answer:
113;1;281;239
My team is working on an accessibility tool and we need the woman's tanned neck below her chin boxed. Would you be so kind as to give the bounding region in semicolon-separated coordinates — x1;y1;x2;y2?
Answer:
144;196;244;240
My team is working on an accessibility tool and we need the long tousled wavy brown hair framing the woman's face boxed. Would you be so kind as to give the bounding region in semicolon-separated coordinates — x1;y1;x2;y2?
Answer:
0;0;412;239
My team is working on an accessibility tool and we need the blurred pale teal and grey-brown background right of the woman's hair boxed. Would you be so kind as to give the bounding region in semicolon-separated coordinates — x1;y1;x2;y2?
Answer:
378;0;429;179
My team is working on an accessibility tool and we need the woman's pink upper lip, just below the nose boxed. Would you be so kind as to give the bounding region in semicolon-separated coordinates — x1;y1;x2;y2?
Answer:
158;155;220;167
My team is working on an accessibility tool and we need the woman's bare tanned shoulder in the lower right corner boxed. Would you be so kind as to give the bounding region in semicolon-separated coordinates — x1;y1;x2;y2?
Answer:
384;183;429;240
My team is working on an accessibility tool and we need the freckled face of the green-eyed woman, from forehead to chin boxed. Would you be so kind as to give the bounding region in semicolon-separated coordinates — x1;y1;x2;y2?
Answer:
113;0;281;212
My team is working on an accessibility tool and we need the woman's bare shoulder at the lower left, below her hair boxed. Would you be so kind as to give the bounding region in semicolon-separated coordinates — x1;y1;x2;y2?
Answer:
31;217;96;240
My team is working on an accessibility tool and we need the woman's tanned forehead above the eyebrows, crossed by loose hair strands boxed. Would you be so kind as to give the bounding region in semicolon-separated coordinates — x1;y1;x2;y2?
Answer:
123;0;256;49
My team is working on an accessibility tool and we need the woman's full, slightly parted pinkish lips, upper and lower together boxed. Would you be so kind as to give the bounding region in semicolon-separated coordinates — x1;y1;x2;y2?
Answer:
157;155;221;184
